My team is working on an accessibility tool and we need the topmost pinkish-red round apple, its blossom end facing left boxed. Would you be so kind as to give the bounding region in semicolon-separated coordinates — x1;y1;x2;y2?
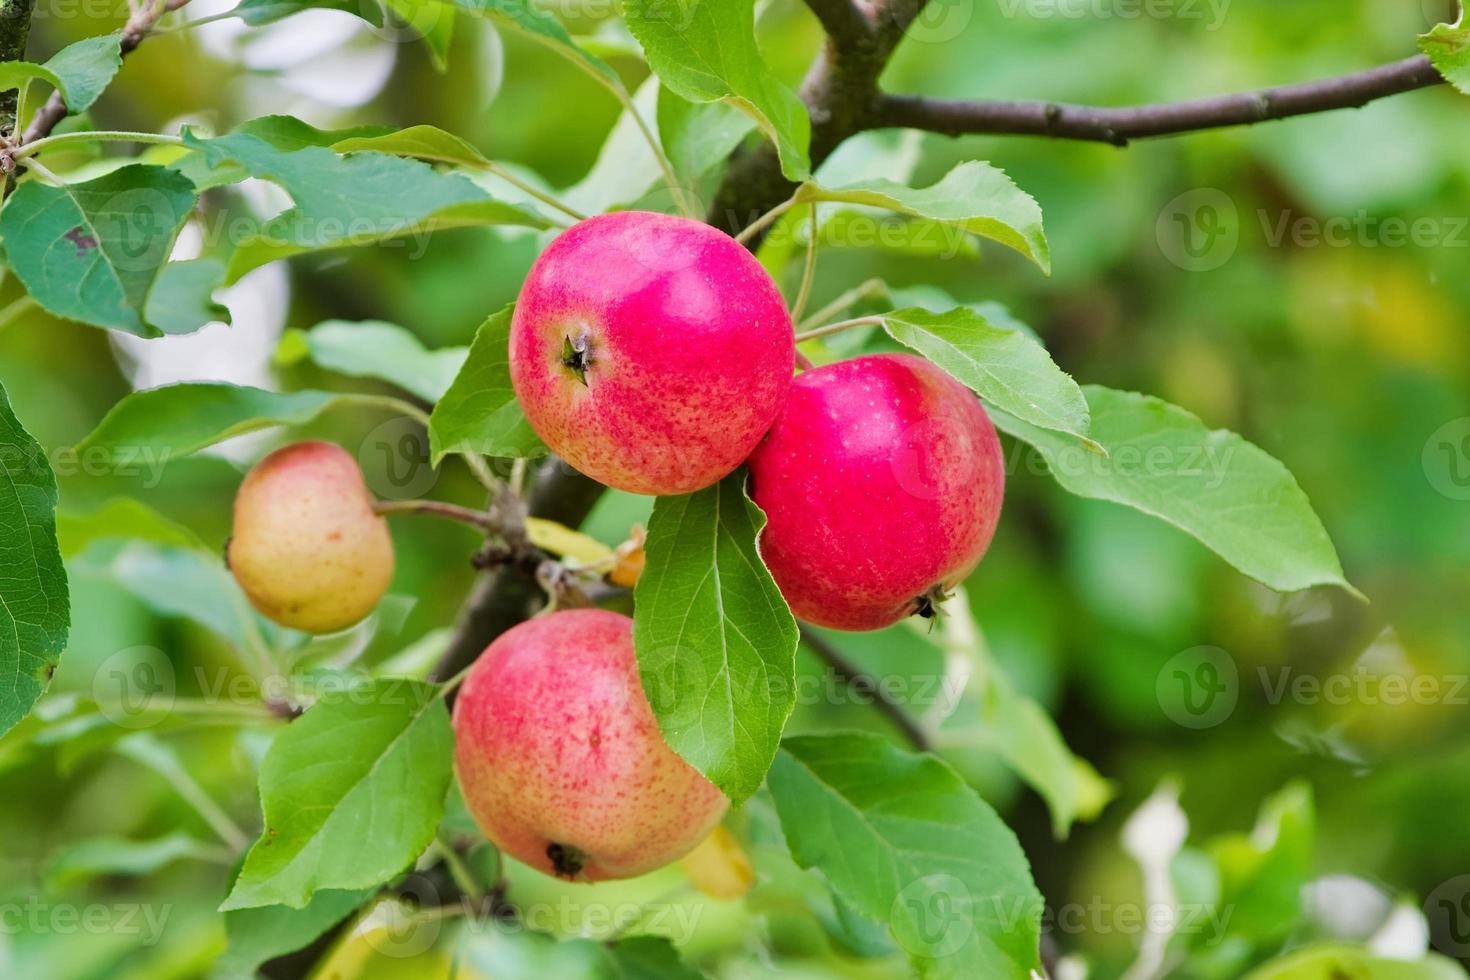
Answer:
510;212;795;495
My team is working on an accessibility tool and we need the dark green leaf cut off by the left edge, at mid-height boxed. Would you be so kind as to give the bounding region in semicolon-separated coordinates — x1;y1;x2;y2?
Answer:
0;388;71;735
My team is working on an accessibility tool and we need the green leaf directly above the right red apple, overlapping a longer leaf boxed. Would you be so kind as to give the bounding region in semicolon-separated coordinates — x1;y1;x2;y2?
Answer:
882;306;1095;445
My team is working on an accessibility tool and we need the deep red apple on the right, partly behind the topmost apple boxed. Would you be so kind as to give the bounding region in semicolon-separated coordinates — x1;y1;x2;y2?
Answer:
750;354;1005;630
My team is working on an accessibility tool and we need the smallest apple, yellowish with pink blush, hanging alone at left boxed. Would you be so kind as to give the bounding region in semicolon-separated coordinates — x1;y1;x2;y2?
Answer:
226;442;394;633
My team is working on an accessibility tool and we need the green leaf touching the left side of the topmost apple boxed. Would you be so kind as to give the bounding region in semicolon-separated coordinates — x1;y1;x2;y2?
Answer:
429;306;547;466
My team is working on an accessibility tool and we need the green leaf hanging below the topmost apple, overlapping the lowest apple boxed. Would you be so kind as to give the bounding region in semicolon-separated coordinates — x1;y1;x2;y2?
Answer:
634;470;797;804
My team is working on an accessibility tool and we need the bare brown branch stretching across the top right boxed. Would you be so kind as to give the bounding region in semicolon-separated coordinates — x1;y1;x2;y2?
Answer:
867;56;1444;147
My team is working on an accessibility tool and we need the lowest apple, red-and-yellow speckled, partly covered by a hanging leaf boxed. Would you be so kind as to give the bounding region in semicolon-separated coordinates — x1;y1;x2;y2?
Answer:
454;610;729;882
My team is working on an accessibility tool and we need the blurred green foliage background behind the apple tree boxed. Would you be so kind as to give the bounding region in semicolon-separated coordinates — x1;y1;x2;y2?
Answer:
0;0;1470;979
